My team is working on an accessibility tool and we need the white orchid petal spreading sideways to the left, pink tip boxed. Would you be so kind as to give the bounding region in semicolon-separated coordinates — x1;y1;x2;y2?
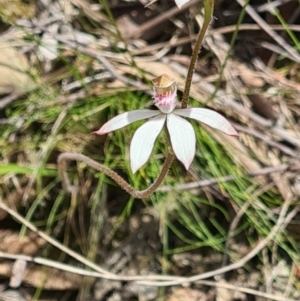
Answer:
94;110;161;135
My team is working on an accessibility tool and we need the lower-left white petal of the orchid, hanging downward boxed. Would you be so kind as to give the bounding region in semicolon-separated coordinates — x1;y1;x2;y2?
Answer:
130;114;166;173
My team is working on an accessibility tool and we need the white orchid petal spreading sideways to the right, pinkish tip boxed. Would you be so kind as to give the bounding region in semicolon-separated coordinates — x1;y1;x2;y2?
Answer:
173;108;239;136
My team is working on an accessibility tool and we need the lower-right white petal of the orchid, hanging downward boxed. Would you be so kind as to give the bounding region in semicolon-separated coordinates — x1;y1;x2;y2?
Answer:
167;114;196;170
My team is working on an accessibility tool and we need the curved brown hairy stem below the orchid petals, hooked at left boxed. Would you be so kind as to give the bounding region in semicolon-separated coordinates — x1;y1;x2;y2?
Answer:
57;152;174;199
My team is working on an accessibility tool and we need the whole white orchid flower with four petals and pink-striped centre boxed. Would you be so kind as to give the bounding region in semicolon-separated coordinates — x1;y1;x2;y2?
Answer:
94;75;238;173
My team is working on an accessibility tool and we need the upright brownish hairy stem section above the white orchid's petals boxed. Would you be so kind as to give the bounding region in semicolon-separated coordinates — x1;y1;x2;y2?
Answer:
181;0;214;109
